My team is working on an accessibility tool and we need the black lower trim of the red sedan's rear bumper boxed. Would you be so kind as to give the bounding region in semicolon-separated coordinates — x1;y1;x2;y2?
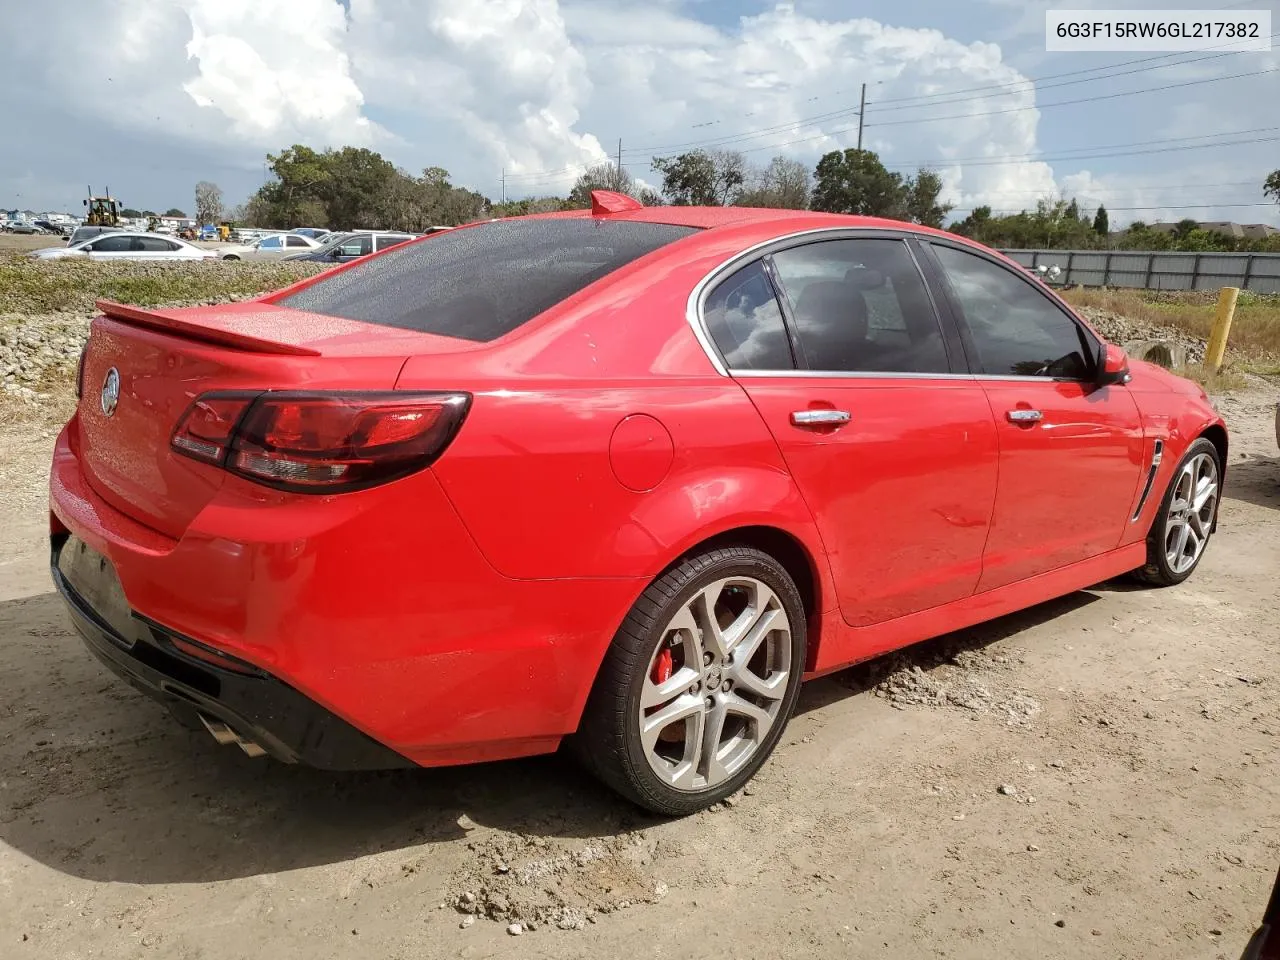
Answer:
50;536;412;771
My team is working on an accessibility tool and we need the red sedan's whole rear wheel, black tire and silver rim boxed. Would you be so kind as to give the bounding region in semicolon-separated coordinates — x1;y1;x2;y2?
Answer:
576;547;805;815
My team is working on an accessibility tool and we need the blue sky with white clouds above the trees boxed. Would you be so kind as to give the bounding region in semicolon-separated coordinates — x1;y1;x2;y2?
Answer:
0;0;1280;224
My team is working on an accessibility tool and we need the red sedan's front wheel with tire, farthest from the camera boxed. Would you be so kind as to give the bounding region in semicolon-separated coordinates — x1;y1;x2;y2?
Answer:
1133;436;1222;586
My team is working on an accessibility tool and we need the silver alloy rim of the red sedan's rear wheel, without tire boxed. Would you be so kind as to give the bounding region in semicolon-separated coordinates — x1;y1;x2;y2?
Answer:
640;576;792;792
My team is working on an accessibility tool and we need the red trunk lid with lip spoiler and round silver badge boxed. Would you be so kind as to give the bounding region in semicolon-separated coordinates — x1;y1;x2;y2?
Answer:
77;301;481;539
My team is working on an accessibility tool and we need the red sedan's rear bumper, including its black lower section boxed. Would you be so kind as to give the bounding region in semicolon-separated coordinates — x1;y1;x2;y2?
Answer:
50;420;644;765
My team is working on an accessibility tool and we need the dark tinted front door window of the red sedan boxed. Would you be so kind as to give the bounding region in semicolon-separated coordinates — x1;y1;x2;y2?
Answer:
933;246;1089;380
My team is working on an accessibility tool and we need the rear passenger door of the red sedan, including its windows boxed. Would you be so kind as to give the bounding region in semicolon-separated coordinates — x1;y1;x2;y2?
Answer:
704;236;997;626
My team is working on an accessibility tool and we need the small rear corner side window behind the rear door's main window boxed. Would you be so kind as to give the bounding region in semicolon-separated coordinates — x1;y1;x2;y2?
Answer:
703;261;795;370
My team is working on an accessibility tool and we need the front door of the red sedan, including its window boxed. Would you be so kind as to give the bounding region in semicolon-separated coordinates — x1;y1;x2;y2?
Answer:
929;242;1147;590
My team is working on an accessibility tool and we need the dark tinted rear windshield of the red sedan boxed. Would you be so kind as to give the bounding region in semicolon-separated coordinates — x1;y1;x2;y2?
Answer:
279;218;696;343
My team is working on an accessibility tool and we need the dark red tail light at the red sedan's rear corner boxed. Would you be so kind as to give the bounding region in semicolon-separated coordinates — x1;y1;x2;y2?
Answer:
170;392;471;493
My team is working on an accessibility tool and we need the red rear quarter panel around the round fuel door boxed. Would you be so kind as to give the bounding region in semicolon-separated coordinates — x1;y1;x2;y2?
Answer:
397;221;829;603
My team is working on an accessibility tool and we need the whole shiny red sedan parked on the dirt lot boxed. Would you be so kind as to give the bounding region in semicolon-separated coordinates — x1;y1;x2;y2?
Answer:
50;193;1228;814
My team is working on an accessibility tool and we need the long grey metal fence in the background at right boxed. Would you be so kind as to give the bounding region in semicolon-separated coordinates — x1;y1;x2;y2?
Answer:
1000;250;1280;293
